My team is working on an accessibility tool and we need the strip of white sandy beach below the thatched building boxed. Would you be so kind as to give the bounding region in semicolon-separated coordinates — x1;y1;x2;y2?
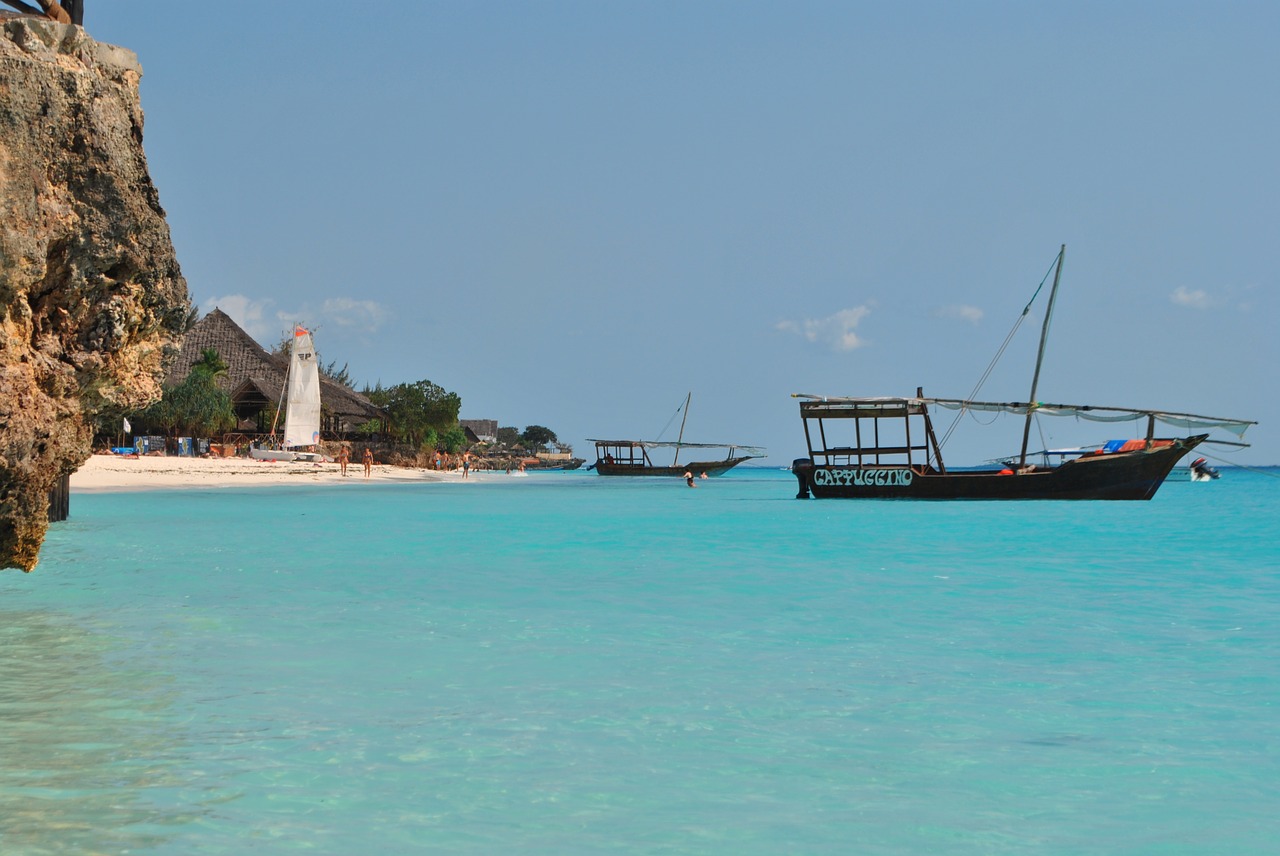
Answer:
72;454;476;493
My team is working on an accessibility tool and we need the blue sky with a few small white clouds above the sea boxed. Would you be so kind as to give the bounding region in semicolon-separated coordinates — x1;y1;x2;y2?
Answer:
86;0;1280;464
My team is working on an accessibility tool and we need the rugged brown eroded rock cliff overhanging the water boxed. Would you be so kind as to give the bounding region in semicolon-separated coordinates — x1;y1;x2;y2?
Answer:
0;14;188;571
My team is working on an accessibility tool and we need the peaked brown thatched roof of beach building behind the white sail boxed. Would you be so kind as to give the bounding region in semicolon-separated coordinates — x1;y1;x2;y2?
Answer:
165;308;381;435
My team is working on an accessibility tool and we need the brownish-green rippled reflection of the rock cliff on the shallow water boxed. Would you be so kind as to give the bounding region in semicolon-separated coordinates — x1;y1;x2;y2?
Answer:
0;609;195;855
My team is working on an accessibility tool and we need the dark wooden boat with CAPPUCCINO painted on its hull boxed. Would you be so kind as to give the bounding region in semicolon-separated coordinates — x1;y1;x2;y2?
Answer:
791;246;1254;499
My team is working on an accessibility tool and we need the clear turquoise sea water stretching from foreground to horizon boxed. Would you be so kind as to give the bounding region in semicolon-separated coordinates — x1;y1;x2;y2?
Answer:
0;470;1280;856
